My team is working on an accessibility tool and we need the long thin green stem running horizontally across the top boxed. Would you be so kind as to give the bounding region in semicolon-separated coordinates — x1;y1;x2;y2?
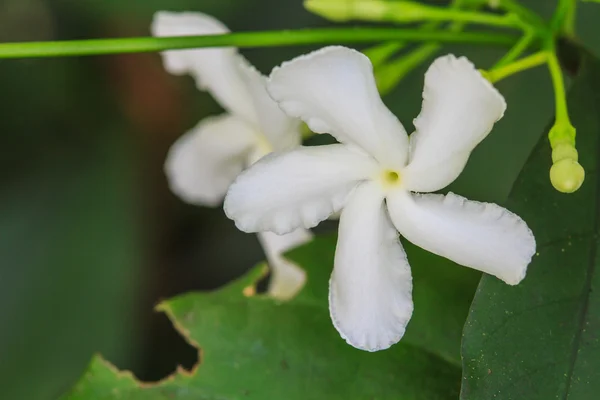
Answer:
0;28;515;58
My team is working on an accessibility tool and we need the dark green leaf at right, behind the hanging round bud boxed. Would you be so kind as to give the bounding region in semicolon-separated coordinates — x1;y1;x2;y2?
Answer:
461;51;600;400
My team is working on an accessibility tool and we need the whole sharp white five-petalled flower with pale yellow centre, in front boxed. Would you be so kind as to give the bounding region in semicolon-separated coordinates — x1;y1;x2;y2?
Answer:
225;47;535;351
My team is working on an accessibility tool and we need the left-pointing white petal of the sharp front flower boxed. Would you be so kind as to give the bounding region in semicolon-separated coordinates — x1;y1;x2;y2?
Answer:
224;144;377;234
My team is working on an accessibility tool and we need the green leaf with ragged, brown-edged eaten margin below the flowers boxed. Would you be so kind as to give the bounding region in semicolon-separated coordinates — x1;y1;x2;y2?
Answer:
63;239;464;400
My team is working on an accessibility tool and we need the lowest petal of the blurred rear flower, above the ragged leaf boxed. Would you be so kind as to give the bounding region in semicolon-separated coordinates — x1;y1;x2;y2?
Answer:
258;229;312;300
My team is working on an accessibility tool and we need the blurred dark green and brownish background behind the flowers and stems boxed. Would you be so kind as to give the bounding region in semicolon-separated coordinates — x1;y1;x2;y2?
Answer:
0;0;600;400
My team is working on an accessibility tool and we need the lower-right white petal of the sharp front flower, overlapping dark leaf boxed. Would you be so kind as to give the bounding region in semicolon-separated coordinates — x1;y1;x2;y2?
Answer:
387;191;535;285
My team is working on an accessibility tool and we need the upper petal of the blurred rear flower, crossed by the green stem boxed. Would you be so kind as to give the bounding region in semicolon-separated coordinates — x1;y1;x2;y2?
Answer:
151;11;257;122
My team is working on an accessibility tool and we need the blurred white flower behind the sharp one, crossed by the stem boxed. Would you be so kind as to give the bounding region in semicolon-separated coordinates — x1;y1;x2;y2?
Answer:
151;11;312;299
